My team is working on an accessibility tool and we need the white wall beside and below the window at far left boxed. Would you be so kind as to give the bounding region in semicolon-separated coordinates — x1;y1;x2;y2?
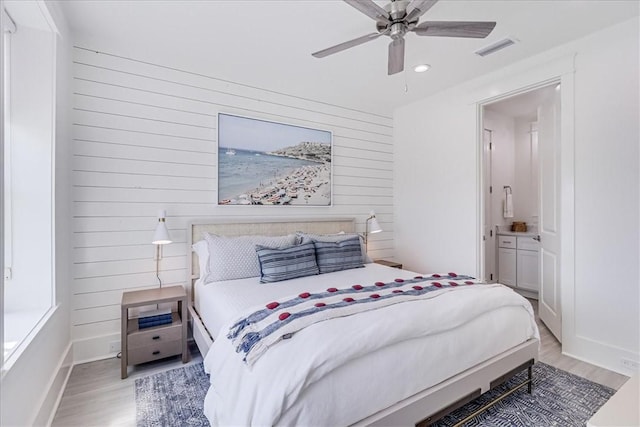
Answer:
0;2;71;426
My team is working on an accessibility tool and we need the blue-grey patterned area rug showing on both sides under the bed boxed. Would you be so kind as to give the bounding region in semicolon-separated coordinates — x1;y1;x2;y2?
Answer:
136;363;615;427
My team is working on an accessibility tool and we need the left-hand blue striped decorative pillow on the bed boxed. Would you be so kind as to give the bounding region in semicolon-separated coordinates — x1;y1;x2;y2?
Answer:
256;240;318;283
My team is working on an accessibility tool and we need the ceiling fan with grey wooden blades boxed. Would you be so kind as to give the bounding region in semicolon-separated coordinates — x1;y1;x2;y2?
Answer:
311;0;496;75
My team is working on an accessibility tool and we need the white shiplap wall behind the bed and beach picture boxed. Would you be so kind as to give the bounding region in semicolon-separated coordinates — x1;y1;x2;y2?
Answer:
72;46;394;361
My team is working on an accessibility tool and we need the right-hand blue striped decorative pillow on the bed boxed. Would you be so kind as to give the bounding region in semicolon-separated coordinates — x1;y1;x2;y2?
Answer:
313;236;364;274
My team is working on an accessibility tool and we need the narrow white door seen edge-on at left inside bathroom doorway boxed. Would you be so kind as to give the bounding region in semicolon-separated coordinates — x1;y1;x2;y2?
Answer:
482;129;497;283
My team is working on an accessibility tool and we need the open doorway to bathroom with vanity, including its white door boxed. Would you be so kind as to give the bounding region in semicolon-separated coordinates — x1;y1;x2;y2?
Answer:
482;82;562;340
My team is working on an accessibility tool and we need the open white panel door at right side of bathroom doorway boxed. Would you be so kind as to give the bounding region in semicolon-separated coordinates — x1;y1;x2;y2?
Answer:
538;92;562;342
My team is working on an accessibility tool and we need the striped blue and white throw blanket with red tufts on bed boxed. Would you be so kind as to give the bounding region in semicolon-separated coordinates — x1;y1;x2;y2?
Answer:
227;273;480;366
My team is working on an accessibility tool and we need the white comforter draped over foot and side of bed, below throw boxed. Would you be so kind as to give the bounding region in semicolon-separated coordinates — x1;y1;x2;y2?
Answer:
204;272;538;426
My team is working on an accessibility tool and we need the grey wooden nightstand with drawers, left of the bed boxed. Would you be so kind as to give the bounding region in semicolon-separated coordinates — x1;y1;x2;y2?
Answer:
120;286;189;379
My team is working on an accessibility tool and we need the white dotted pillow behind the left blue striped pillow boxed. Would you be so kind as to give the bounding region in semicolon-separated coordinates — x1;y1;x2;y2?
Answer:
204;233;298;283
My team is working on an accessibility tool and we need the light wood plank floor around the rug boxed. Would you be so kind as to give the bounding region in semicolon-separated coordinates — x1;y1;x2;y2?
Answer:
52;300;628;427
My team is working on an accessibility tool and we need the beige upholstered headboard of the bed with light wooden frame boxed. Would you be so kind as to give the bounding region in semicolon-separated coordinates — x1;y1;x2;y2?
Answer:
187;218;355;298
